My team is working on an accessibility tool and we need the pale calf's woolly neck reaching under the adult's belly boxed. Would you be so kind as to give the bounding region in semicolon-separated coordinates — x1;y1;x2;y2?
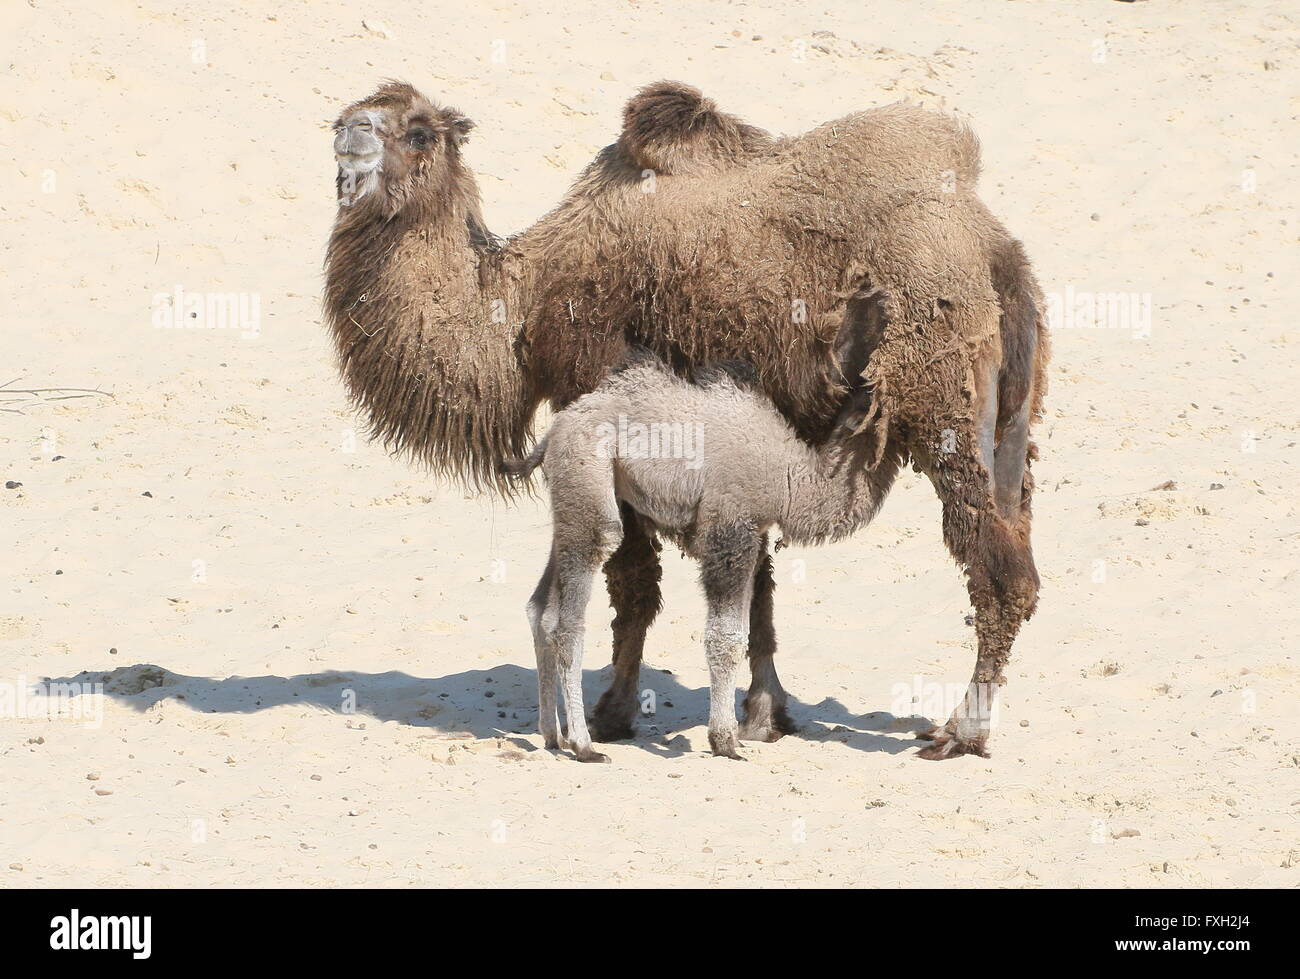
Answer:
781;434;883;543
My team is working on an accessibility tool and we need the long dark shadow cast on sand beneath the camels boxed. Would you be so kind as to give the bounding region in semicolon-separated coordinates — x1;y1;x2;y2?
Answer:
47;663;931;758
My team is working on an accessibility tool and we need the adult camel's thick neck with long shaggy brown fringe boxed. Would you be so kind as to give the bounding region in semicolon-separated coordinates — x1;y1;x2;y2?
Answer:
325;184;533;488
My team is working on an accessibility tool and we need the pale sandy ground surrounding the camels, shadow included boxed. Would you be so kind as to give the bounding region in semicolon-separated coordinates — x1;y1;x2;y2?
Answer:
0;0;1300;887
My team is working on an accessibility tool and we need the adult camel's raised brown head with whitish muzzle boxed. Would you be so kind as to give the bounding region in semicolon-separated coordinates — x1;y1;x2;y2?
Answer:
334;82;475;213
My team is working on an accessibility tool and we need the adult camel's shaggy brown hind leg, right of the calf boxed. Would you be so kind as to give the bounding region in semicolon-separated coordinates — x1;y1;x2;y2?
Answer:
913;374;1039;759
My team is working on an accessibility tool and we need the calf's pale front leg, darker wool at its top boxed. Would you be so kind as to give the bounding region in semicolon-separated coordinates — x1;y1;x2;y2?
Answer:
699;525;762;759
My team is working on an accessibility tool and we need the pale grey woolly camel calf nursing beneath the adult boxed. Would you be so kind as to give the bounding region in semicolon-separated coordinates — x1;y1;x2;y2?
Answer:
503;356;900;762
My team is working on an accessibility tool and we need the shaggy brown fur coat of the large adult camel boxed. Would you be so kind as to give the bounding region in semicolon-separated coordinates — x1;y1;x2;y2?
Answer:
326;82;1048;755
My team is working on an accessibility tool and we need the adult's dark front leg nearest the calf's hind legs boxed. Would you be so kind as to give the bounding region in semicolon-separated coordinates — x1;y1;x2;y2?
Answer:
592;503;663;741
